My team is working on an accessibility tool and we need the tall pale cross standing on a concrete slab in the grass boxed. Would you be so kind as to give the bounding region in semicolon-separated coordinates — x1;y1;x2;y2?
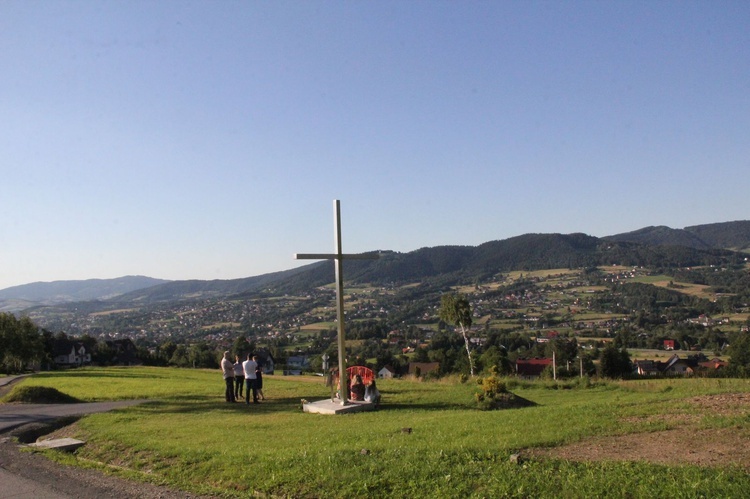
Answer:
294;199;378;405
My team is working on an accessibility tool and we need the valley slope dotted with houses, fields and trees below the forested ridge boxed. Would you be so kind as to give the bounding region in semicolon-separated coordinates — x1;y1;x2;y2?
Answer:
19;267;748;379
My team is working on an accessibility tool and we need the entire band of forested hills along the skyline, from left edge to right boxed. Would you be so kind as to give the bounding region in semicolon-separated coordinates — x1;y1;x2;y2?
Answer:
0;221;750;311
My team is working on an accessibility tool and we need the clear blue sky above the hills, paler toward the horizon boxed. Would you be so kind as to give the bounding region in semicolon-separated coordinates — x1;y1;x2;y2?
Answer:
0;0;750;289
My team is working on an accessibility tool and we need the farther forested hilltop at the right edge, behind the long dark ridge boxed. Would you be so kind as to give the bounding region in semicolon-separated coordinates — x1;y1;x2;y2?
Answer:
604;220;750;251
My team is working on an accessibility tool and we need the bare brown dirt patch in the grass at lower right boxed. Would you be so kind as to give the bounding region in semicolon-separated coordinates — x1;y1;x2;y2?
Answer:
524;393;750;472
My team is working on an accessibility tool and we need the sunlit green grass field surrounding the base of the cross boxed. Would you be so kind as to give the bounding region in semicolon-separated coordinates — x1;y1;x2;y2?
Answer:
10;368;750;497
